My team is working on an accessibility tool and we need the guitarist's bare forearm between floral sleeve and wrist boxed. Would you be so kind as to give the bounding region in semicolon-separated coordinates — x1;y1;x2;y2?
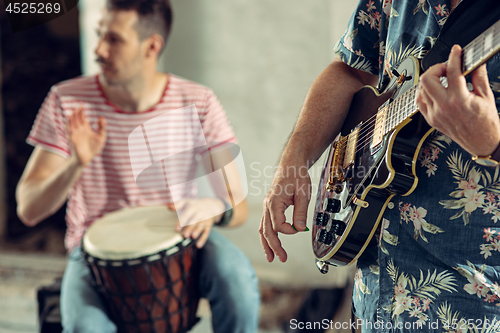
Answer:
280;59;376;167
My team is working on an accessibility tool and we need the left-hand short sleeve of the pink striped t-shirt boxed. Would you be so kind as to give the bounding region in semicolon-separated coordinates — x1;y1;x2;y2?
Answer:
26;86;70;158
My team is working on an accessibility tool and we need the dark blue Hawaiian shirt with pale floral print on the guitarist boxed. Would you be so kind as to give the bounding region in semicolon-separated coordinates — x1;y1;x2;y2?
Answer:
335;0;500;332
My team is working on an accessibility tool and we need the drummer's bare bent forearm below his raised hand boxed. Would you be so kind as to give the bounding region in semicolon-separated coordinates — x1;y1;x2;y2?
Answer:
16;156;83;226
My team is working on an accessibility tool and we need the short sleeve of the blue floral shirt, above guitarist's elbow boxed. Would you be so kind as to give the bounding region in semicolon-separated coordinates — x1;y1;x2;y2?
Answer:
334;0;384;75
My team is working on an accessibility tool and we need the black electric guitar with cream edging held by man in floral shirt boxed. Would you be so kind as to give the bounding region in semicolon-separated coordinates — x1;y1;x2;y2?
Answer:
312;17;500;273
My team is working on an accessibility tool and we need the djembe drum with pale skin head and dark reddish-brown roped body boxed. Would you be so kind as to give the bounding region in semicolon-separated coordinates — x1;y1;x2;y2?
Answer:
83;206;200;333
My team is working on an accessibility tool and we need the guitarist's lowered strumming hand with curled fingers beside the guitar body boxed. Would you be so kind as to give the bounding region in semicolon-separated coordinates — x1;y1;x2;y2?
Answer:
259;165;311;262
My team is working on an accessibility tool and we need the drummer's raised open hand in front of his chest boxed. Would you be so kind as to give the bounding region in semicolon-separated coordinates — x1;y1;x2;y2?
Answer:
67;105;106;166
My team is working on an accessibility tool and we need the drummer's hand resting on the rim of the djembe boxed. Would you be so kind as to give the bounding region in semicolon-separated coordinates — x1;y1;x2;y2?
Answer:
173;198;225;249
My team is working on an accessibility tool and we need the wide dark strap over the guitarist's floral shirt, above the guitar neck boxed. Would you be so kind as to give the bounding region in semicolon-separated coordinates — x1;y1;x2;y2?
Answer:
422;0;500;71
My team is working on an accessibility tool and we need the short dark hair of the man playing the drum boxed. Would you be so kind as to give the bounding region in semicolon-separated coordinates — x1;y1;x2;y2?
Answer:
106;0;173;43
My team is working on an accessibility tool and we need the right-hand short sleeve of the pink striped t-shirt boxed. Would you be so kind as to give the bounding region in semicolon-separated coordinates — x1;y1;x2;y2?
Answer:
202;91;237;147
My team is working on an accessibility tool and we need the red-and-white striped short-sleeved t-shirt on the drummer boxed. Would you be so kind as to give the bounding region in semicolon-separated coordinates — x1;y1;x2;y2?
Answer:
26;74;236;251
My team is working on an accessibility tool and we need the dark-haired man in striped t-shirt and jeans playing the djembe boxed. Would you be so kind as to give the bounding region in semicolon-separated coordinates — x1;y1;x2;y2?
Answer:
16;0;260;333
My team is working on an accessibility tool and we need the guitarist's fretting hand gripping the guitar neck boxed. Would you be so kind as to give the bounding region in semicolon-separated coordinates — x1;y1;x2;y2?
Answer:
416;45;500;156
